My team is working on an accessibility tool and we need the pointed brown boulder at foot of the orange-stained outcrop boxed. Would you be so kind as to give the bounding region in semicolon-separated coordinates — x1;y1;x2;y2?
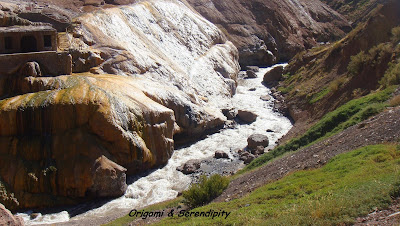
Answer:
89;155;127;197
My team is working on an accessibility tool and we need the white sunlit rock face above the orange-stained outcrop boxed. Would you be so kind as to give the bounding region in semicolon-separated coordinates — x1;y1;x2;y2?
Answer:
75;1;239;139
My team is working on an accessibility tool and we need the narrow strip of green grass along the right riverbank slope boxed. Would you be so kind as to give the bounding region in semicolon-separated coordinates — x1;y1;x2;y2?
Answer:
238;86;395;174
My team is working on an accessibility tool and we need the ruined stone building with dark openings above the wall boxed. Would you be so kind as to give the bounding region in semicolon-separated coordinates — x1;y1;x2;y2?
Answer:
0;26;57;54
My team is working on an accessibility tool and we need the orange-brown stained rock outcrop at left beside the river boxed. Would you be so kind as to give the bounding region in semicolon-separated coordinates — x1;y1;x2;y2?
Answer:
0;75;175;210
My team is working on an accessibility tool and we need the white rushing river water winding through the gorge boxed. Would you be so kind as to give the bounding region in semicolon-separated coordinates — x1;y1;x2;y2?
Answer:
19;65;292;225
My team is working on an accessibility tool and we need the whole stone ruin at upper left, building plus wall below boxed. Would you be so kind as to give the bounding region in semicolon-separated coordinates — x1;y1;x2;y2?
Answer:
0;25;72;77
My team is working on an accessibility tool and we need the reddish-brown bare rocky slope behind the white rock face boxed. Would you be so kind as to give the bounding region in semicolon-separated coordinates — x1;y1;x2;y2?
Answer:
188;0;350;66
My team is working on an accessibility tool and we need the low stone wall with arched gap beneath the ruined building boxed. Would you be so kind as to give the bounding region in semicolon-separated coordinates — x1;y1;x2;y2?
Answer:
0;51;72;77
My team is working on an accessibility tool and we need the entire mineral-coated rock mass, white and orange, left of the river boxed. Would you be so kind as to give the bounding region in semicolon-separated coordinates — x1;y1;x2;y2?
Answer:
0;1;239;210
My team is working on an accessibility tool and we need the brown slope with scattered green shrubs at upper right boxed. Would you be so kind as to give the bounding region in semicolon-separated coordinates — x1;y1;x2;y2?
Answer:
278;1;400;139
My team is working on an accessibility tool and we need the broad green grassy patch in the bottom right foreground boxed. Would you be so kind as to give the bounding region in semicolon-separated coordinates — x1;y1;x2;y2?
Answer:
158;144;400;225
